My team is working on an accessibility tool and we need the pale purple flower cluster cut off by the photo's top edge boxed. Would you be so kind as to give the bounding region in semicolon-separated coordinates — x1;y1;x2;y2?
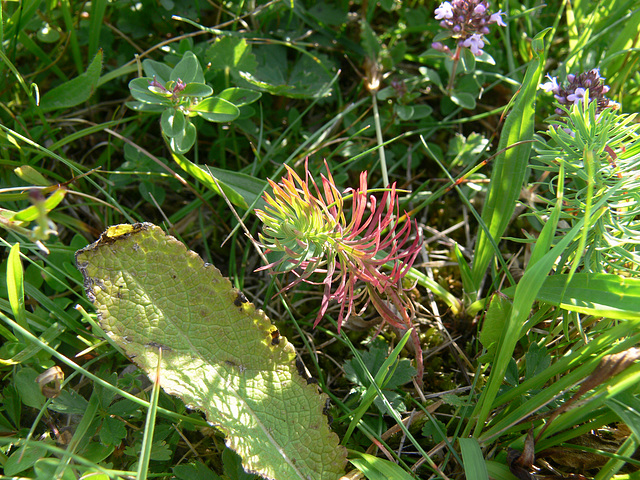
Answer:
431;0;506;55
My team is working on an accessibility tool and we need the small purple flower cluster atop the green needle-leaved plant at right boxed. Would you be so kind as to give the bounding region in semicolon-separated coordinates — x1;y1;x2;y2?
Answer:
540;68;617;115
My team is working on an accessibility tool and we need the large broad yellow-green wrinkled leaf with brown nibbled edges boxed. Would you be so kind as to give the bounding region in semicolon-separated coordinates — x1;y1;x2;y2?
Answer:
76;223;346;480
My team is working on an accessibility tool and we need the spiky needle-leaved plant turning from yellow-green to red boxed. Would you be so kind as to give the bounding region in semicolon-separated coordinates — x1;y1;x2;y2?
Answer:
256;163;423;381
